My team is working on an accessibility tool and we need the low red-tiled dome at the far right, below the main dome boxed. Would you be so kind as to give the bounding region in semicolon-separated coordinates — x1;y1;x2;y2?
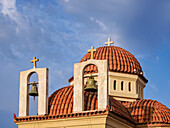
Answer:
122;99;170;124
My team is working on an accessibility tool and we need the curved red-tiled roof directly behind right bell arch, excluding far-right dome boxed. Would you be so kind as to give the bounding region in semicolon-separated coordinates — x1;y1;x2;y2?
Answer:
49;86;132;121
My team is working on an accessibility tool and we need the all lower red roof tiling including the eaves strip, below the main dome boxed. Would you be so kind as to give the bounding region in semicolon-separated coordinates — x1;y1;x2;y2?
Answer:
14;85;170;127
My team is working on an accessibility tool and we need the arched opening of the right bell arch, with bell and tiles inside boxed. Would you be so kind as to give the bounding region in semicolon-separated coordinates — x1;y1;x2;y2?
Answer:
83;64;98;111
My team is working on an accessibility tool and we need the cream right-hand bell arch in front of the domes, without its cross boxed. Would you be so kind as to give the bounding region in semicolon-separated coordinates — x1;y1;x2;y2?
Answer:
73;59;108;112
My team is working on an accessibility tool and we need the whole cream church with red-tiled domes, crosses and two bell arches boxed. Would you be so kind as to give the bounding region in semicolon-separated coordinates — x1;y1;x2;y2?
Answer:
14;38;170;128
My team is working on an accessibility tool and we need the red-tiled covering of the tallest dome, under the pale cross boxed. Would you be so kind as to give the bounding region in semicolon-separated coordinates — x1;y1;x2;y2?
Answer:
68;46;148;82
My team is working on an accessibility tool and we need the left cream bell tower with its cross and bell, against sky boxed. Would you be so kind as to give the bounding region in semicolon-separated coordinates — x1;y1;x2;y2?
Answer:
19;57;48;117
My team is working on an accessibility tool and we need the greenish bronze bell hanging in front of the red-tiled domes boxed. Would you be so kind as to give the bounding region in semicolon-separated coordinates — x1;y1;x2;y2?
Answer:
84;76;97;92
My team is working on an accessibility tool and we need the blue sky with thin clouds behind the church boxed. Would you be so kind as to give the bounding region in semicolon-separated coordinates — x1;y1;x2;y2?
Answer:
0;0;170;128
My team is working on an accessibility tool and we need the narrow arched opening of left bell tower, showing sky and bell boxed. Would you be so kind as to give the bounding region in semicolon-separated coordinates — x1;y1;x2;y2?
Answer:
28;72;38;116
